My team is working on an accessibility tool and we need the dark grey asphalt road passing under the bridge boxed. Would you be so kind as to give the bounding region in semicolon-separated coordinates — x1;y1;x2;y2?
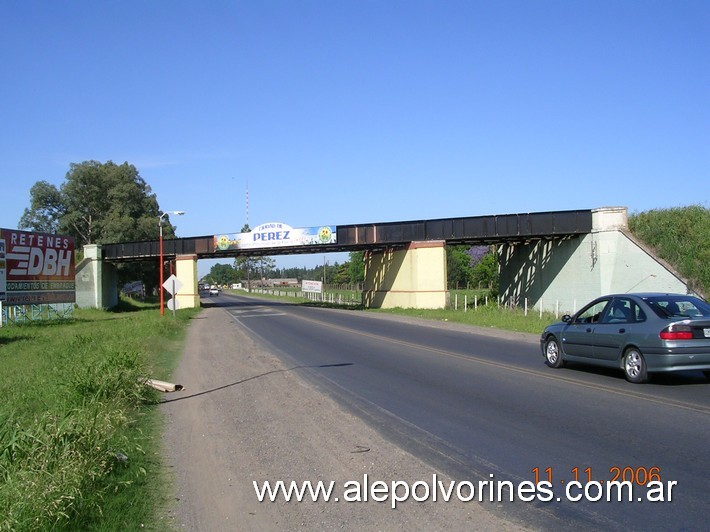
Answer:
202;295;710;530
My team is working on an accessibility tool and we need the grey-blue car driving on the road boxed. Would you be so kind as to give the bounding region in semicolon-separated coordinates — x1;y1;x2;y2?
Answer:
540;293;710;383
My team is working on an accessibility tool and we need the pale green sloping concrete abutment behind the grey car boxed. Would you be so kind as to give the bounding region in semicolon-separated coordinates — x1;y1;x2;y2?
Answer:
499;207;688;312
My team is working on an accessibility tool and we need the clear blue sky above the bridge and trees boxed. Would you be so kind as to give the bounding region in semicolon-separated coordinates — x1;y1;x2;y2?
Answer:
0;0;710;273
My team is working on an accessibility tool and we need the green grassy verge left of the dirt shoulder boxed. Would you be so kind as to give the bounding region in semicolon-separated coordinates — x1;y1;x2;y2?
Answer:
0;303;199;530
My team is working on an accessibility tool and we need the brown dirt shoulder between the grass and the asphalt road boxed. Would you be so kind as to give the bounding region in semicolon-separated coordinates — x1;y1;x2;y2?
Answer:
162;308;521;531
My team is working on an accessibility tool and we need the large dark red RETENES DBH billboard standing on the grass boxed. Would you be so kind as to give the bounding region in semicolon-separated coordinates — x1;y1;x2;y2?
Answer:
0;229;76;305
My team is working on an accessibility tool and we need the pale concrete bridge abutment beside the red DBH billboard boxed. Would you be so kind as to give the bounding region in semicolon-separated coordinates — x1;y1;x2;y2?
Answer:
75;244;118;308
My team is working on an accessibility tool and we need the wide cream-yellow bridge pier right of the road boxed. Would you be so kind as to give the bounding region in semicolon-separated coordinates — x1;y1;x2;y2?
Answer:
362;240;448;309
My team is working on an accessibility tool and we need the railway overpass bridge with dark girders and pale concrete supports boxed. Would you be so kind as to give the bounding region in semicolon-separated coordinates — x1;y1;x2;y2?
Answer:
76;207;688;312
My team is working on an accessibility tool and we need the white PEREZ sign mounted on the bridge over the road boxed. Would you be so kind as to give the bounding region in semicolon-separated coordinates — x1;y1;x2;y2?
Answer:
214;222;336;251
